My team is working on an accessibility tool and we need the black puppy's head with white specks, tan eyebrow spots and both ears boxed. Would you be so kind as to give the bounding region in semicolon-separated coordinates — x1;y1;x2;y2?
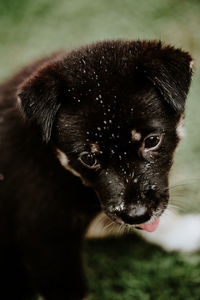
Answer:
19;41;192;230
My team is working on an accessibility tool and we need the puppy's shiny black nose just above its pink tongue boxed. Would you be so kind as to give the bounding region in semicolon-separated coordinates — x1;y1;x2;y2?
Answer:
116;206;151;225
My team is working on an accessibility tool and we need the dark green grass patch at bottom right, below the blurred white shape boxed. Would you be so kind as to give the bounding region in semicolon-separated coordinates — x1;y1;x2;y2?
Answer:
85;235;200;300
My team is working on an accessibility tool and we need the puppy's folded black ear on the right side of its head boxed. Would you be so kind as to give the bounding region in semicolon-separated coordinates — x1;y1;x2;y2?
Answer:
143;44;193;113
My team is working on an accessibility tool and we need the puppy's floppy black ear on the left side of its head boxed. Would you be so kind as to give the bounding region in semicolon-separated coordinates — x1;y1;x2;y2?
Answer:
18;62;66;142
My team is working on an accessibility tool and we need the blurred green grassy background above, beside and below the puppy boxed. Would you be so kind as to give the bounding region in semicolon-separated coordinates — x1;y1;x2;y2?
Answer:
0;0;200;300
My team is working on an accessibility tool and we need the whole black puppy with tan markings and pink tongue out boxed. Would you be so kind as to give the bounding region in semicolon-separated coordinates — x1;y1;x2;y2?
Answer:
0;41;192;300
